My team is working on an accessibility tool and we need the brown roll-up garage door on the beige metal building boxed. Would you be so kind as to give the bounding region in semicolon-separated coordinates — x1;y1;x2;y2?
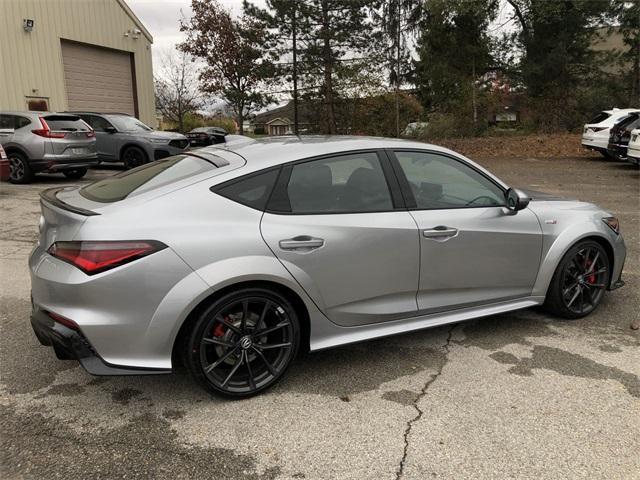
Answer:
62;40;137;115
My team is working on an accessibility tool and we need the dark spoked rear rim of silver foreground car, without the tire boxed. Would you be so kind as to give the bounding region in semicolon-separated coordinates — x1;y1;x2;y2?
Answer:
199;296;296;395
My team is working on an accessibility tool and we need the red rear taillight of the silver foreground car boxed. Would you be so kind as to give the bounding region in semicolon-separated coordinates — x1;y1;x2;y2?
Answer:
47;240;167;275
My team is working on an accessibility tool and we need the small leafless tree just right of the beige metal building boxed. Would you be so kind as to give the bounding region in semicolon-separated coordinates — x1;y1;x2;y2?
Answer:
154;50;202;132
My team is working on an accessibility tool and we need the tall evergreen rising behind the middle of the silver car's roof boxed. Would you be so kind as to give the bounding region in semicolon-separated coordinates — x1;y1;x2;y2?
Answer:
244;0;377;134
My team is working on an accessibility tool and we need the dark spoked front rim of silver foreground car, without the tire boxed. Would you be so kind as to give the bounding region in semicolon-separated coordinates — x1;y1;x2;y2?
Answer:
560;247;609;315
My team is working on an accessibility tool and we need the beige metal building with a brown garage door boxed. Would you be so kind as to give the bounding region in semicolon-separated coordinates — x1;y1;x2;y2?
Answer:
0;0;155;126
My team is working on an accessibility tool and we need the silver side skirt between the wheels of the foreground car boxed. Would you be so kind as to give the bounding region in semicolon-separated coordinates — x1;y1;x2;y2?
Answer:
310;296;544;351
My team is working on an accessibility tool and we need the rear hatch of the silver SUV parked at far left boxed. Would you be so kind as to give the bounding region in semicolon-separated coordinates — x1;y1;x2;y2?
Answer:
33;113;96;157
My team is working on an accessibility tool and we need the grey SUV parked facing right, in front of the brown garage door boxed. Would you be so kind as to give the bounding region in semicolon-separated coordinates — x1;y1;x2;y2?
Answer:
74;112;189;169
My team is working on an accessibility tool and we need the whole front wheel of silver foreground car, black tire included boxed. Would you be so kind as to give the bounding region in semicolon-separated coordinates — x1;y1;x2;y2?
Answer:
544;240;611;320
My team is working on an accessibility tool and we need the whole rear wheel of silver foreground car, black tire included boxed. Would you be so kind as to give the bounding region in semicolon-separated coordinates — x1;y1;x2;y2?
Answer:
182;288;300;398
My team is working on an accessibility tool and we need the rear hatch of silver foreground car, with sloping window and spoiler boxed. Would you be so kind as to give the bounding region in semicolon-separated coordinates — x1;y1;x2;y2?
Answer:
40;150;245;248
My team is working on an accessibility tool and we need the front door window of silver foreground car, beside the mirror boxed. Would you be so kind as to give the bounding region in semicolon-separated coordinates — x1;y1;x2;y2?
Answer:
395;152;505;210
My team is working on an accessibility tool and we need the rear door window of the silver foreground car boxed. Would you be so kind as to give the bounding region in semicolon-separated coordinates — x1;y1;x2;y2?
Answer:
278;152;393;214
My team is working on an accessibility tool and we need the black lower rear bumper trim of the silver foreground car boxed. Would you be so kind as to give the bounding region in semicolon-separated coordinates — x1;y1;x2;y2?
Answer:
31;307;171;375
